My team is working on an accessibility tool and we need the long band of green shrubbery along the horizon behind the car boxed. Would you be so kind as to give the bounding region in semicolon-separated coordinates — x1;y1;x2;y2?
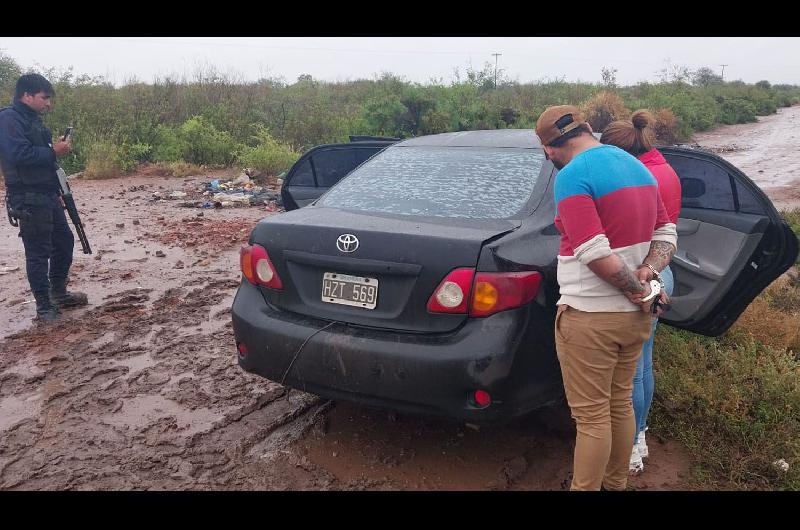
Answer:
0;55;800;173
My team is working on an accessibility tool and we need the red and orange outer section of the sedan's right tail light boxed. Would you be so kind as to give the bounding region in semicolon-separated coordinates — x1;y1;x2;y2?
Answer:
469;272;542;317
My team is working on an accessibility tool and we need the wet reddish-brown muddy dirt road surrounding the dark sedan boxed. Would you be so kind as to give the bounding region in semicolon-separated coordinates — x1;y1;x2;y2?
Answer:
0;107;800;490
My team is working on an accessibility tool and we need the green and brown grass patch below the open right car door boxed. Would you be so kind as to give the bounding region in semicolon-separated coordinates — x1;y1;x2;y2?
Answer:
652;251;800;490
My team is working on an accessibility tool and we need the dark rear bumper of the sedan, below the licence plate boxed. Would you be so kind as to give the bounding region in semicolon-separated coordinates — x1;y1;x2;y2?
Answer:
232;281;561;423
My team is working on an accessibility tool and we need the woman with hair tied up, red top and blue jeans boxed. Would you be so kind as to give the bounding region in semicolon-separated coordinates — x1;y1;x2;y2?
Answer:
600;110;681;474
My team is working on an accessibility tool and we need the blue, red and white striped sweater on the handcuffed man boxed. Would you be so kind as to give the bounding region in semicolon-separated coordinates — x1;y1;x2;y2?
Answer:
555;145;678;312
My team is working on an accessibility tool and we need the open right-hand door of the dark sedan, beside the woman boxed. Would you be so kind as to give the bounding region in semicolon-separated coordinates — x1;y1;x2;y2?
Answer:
661;148;798;335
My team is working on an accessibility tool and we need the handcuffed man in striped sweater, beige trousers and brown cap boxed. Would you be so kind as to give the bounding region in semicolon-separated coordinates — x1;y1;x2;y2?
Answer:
536;105;677;490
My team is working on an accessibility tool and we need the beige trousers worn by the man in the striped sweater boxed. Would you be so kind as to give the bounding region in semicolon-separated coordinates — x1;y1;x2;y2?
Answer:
555;305;651;490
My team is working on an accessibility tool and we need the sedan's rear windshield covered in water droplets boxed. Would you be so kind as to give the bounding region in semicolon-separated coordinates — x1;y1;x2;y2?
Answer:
318;146;544;219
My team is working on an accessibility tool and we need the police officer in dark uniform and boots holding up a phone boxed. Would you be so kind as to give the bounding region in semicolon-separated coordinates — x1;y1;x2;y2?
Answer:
0;74;88;321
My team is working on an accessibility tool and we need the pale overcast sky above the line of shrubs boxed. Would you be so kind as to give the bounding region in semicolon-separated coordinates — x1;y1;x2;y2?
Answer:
0;37;800;85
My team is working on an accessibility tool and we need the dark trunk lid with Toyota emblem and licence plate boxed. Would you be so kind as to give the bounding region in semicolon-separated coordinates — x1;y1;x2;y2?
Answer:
251;207;520;332
